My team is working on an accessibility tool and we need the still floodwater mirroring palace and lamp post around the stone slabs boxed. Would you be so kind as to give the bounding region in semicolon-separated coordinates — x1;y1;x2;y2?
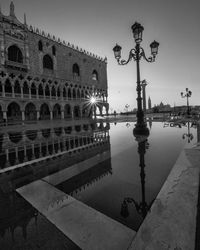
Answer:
0;121;196;249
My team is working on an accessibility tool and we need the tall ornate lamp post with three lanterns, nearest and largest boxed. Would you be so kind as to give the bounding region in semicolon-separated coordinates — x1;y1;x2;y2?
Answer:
113;22;159;135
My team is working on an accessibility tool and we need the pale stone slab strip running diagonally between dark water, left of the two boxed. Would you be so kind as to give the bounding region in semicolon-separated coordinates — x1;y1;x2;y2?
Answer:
17;180;135;250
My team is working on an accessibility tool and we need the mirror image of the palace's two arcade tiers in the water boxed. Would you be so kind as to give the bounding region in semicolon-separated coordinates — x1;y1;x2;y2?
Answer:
0;122;109;172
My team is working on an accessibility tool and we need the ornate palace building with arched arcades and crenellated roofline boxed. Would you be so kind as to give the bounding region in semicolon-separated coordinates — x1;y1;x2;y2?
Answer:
0;2;108;121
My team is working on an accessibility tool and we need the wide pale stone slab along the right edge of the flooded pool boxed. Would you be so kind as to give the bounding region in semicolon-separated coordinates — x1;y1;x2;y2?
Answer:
129;147;200;250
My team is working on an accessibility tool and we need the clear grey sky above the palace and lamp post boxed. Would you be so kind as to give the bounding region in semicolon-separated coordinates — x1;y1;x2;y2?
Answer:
0;0;200;112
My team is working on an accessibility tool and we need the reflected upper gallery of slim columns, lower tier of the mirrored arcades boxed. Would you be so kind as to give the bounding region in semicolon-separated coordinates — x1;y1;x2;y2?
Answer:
0;135;109;169
